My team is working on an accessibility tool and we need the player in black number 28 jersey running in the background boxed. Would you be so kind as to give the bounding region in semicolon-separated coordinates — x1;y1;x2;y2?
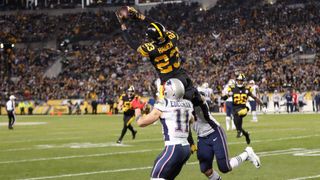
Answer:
225;73;262;144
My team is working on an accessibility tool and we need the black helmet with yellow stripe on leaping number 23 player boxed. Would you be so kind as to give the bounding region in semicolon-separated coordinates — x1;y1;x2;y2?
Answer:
146;22;166;43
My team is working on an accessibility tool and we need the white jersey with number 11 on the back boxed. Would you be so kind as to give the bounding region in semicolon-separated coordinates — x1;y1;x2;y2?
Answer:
154;99;193;145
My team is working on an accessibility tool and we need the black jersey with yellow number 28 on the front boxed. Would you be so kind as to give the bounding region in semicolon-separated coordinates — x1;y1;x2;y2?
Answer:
228;86;252;108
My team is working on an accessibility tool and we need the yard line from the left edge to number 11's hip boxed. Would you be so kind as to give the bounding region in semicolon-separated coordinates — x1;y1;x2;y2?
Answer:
0;149;162;164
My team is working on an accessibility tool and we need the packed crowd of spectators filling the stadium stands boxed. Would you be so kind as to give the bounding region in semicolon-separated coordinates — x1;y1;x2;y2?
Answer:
0;0;320;102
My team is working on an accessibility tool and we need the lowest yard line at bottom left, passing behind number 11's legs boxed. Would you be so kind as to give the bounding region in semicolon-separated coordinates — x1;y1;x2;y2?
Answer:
18;161;199;180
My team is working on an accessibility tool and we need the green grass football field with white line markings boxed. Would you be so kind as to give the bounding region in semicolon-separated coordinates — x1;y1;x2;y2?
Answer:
0;114;320;180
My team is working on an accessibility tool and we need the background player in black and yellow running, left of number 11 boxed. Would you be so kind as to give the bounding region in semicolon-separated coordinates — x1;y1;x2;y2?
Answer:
117;86;137;144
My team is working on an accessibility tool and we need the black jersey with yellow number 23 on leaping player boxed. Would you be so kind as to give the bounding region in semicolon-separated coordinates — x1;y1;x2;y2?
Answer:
137;31;181;79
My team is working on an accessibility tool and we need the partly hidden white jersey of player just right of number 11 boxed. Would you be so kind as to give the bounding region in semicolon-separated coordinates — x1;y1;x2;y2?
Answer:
192;106;214;137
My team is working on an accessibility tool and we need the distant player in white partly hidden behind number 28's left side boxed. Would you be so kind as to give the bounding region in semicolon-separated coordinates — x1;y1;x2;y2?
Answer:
222;79;236;131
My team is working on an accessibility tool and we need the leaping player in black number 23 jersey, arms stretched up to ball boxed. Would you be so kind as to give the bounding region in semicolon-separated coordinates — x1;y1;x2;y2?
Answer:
116;6;218;136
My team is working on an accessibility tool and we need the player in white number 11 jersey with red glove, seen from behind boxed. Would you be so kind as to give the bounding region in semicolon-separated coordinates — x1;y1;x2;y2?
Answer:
132;78;193;179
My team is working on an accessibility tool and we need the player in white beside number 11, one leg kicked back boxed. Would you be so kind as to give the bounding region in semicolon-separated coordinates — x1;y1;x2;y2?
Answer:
192;107;261;180
